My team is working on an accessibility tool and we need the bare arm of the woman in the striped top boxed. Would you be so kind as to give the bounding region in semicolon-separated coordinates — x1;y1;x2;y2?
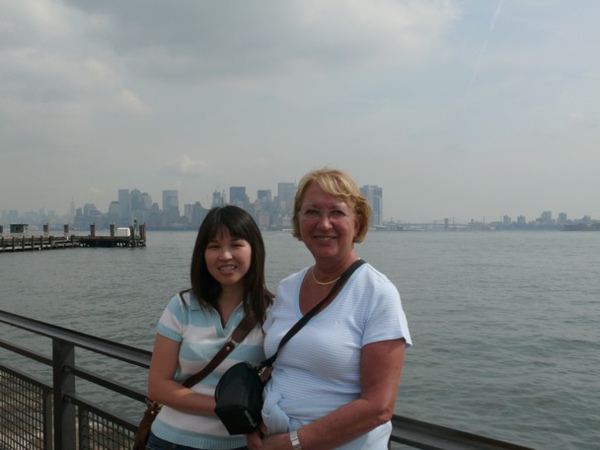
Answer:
148;334;215;414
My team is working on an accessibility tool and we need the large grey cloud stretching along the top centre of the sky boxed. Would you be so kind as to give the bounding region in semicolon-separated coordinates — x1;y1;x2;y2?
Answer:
58;0;457;85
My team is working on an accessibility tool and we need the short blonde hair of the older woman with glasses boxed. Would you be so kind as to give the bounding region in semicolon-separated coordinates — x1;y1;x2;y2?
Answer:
292;167;371;242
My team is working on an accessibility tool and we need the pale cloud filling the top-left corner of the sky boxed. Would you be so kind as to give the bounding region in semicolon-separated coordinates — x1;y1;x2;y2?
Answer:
0;0;151;134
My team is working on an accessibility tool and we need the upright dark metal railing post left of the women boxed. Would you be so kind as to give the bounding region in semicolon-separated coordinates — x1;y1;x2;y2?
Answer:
52;339;77;450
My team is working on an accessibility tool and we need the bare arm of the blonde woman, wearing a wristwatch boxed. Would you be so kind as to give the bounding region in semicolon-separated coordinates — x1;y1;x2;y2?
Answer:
253;339;405;450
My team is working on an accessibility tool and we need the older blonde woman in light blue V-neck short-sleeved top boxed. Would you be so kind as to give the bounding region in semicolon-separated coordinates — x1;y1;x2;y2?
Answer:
248;168;411;450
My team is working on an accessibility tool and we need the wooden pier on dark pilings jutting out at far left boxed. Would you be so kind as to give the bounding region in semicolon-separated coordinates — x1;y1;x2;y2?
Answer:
0;225;146;253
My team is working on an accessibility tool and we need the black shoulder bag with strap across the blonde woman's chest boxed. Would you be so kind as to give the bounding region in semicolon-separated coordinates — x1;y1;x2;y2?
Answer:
215;259;365;434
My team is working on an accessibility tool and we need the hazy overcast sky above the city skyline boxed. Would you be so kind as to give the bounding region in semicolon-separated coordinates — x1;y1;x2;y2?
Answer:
0;0;600;223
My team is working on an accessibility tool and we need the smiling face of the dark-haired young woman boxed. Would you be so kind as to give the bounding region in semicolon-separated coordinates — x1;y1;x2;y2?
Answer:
204;229;252;288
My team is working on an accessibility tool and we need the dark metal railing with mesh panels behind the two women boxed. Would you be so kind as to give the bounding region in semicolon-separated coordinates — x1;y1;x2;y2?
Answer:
0;311;527;450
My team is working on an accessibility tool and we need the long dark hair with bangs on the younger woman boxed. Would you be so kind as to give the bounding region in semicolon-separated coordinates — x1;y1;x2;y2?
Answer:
190;205;273;323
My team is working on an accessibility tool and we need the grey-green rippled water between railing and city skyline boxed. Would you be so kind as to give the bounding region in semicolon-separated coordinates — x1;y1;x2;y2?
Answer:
0;231;600;449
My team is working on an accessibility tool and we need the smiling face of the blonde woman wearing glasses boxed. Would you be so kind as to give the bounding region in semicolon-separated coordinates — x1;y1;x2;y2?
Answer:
299;183;360;264
